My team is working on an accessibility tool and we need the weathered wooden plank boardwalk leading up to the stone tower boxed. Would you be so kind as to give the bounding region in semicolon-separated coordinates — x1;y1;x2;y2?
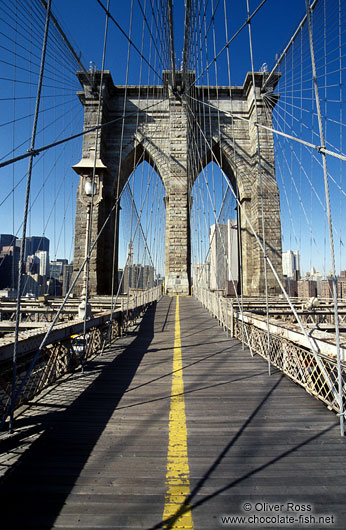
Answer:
0;297;346;530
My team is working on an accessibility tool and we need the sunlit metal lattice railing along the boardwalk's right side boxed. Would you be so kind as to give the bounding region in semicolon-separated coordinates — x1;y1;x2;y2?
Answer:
193;286;346;413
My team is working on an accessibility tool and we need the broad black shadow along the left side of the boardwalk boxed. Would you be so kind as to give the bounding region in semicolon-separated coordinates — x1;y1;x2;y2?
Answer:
0;303;156;528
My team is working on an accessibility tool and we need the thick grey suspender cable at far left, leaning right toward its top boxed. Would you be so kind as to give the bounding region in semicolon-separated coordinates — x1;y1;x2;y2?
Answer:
9;0;51;433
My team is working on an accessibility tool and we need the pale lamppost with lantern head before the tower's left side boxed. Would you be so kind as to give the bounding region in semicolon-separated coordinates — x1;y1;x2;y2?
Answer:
72;156;108;318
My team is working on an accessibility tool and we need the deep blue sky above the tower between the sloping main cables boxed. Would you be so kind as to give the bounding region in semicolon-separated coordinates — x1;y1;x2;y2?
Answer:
53;0;305;84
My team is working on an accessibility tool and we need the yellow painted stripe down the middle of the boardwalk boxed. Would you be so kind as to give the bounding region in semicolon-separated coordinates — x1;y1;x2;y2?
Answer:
163;296;193;529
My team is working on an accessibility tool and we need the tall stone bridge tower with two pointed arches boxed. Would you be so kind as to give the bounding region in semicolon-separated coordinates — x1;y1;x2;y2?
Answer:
74;71;281;295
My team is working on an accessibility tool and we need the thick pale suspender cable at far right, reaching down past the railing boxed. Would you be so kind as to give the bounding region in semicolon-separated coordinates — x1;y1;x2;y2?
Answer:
305;0;345;436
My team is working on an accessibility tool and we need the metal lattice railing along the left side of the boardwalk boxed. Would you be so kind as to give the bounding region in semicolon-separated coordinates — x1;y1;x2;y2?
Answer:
0;286;162;420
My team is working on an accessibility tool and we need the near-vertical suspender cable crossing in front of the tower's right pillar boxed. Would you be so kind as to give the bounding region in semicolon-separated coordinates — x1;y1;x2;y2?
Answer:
246;0;271;375
